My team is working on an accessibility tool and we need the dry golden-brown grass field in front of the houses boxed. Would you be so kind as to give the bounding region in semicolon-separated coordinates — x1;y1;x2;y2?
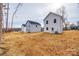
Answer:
0;31;79;56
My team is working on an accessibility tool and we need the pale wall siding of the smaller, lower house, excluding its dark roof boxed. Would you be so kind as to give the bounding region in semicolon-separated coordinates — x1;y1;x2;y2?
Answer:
22;22;41;32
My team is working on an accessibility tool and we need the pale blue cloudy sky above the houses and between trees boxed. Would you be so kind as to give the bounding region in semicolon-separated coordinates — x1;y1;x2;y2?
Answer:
4;3;79;27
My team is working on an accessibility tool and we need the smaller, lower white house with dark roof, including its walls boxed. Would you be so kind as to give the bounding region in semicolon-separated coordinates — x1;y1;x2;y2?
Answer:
21;20;41;32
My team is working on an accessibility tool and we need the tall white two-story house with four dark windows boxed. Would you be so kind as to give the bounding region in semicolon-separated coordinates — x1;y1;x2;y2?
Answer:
43;12;63;33
